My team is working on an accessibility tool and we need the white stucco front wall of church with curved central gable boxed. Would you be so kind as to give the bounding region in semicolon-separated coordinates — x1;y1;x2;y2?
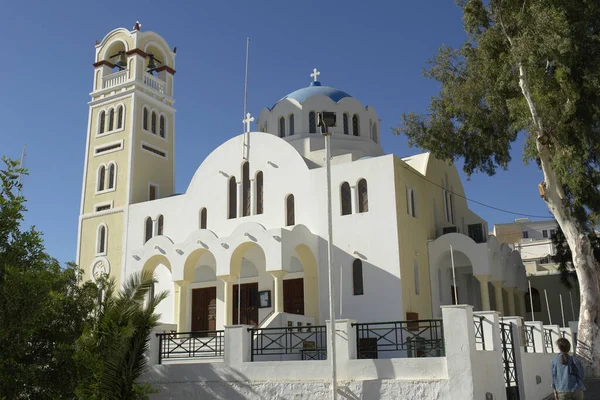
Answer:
125;133;405;327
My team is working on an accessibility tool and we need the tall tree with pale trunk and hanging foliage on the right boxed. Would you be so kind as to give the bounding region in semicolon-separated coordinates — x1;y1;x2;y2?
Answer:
395;0;600;376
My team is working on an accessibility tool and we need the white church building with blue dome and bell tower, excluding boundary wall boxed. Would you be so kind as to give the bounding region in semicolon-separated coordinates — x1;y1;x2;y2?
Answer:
77;24;527;332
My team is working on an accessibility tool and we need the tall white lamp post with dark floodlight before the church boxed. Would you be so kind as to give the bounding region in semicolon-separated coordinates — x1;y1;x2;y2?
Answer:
318;111;337;400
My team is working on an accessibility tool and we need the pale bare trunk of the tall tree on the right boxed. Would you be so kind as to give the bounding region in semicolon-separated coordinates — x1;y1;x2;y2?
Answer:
519;64;600;377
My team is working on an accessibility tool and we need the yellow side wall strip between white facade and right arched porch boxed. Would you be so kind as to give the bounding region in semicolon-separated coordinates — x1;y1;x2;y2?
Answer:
394;157;431;319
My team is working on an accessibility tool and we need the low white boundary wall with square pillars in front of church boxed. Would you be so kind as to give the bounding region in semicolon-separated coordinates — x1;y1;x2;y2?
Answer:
143;305;558;400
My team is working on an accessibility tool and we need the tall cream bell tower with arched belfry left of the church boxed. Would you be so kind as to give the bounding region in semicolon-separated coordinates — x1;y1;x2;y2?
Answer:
77;22;176;285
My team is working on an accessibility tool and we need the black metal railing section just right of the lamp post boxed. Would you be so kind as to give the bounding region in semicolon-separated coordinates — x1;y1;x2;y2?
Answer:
352;319;445;359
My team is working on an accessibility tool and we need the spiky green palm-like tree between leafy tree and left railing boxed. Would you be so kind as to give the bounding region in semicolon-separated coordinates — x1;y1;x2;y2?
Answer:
75;272;168;400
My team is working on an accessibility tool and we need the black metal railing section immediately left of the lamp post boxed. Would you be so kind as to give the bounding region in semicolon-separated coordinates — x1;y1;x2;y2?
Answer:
248;325;327;361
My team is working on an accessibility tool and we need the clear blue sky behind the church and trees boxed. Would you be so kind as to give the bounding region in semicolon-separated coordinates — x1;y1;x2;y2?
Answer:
0;0;549;262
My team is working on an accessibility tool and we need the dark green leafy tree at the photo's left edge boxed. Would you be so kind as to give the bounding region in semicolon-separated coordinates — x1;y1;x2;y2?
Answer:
0;158;97;399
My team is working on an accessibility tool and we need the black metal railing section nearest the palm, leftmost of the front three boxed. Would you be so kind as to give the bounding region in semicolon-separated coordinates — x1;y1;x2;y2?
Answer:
156;331;225;364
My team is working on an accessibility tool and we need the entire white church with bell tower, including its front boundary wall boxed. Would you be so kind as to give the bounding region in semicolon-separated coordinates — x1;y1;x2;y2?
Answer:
71;23;574;400
